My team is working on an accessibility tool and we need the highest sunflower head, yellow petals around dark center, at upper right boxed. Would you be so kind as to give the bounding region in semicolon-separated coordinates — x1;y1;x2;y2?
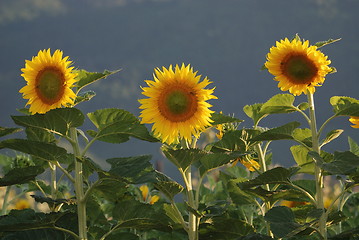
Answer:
265;38;331;96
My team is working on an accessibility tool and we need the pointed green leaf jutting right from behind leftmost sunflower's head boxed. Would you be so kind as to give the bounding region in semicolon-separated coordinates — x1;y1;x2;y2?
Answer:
76;69;121;95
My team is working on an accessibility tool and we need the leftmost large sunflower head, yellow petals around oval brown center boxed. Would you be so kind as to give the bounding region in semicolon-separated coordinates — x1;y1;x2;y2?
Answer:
19;49;77;114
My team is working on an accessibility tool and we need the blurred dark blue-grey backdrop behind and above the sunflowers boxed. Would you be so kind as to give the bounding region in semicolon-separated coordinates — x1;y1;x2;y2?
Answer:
0;0;359;178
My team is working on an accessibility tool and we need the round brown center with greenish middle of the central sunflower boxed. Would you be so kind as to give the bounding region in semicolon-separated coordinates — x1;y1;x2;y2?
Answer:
158;84;198;122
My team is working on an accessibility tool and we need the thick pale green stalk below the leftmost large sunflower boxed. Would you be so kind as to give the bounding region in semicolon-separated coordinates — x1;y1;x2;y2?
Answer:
70;128;87;240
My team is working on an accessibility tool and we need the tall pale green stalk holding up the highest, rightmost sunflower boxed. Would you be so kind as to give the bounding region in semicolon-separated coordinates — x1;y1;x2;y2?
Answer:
307;91;328;240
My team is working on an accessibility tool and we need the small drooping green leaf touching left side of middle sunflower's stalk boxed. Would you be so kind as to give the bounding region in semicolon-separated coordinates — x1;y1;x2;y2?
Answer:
153;171;184;200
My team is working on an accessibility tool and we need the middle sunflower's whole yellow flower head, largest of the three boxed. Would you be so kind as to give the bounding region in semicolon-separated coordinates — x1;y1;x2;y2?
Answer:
139;64;217;144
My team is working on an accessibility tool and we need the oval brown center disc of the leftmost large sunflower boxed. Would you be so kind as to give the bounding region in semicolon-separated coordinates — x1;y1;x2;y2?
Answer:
36;67;65;105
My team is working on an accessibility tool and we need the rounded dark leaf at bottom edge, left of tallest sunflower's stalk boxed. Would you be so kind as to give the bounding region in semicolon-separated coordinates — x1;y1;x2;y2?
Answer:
264;206;301;238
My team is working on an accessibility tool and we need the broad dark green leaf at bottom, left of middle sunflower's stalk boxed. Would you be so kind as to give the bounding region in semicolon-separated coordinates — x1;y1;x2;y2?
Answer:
113;200;171;231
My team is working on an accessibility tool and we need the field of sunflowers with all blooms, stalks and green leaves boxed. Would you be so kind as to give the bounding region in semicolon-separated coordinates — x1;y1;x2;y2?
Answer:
0;35;359;240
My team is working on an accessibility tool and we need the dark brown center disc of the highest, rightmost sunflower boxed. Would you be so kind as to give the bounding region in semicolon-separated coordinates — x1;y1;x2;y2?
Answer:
280;54;318;85
